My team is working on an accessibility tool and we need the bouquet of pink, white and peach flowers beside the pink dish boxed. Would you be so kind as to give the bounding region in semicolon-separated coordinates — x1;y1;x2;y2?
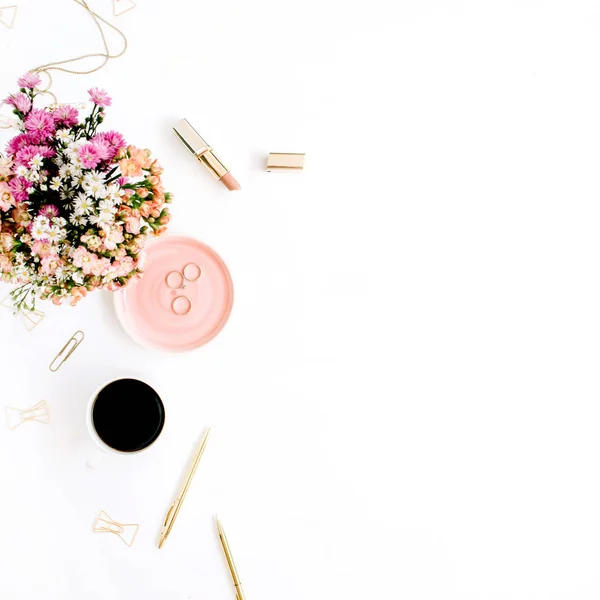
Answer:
0;73;171;311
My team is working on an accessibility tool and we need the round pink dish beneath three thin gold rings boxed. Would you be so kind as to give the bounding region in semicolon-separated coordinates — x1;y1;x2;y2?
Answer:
115;236;233;352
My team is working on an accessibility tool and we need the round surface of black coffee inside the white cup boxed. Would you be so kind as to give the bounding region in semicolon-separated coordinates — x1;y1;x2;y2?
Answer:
92;379;165;452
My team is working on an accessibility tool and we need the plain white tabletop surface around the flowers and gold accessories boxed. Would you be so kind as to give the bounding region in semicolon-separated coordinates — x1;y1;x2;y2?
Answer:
0;0;600;600
